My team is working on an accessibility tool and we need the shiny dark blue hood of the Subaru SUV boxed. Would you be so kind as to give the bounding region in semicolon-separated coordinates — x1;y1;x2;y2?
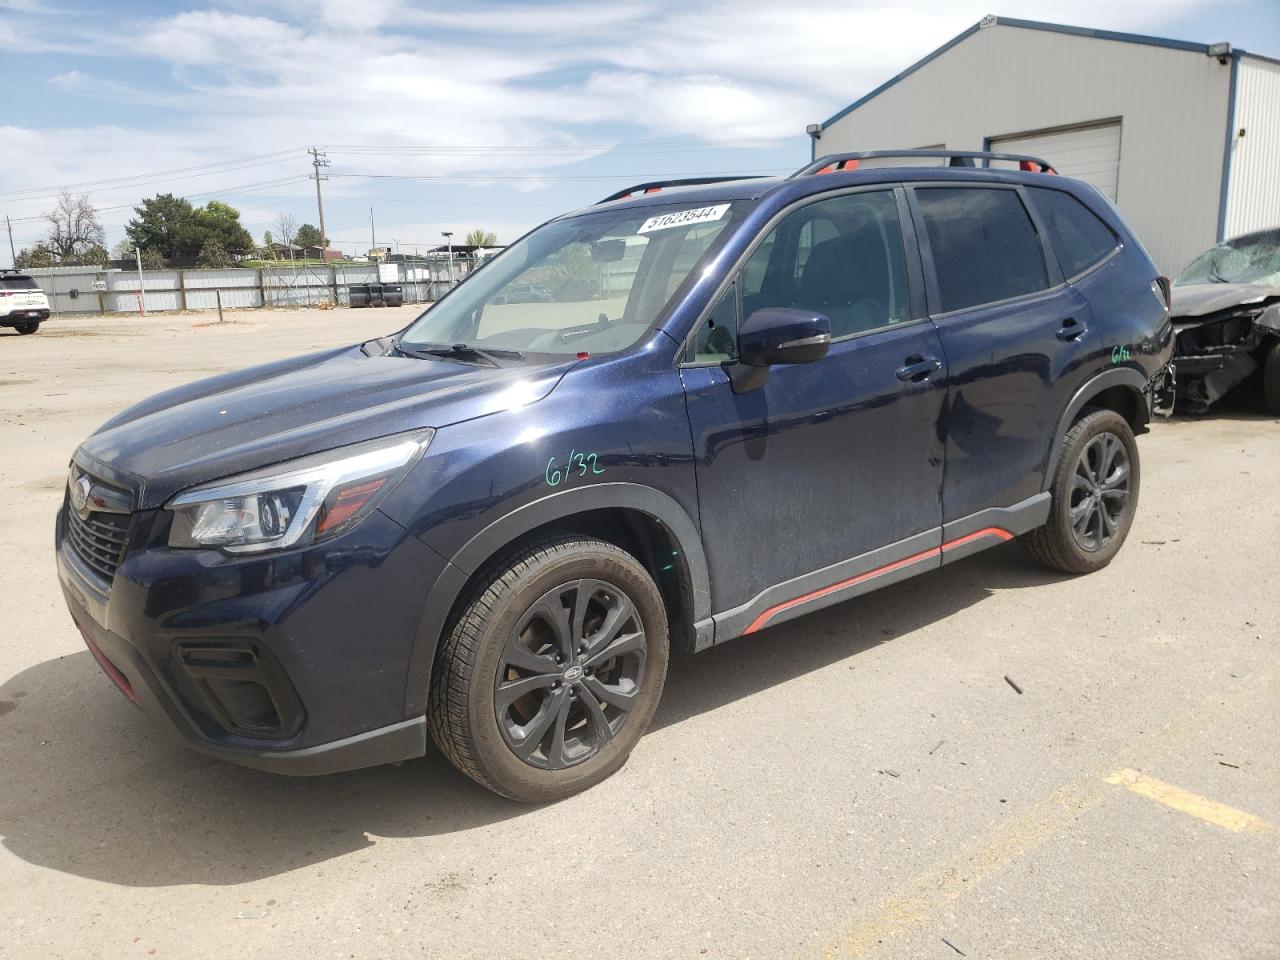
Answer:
76;346;576;509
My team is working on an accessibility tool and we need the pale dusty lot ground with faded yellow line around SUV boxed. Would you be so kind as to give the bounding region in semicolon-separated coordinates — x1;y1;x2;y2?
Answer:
0;307;1280;960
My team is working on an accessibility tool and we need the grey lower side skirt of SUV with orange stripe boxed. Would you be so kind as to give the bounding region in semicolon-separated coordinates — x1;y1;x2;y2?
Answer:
698;493;1050;649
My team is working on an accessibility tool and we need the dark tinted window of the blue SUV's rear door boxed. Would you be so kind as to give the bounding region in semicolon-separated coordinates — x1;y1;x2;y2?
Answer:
915;187;1048;314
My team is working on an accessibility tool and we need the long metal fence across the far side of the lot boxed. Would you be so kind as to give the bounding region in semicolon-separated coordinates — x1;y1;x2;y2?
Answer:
27;260;476;314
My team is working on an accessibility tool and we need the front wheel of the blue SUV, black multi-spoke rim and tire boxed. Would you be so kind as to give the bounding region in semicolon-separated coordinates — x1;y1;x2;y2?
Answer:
428;535;669;803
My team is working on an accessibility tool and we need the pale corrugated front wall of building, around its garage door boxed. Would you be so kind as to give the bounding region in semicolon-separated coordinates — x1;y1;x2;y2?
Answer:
818;23;1231;275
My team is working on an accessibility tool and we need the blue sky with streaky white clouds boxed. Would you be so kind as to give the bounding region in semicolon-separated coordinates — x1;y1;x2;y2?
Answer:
0;0;1280;262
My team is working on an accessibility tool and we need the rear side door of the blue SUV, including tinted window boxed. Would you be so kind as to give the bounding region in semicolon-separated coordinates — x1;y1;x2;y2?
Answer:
910;183;1091;536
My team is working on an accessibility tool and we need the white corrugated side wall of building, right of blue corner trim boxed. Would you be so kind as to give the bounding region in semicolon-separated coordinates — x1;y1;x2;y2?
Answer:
1224;56;1280;237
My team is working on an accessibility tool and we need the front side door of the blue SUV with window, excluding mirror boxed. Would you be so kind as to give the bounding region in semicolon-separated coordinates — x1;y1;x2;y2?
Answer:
682;188;946;640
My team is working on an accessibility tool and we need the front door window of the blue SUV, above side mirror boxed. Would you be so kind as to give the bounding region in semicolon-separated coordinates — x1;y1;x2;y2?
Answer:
742;189;911;338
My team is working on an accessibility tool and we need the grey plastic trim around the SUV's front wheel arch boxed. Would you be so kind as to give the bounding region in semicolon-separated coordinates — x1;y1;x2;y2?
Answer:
404;483;712;717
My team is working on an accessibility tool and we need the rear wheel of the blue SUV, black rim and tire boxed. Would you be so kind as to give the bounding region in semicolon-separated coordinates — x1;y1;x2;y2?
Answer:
1019;410;1142;573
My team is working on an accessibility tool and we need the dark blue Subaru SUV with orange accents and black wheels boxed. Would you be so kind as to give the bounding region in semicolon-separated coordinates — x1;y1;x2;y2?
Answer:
56;151;1171;801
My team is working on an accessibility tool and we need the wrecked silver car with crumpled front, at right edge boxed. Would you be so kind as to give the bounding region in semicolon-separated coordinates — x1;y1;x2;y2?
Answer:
1171;227;1280;416
